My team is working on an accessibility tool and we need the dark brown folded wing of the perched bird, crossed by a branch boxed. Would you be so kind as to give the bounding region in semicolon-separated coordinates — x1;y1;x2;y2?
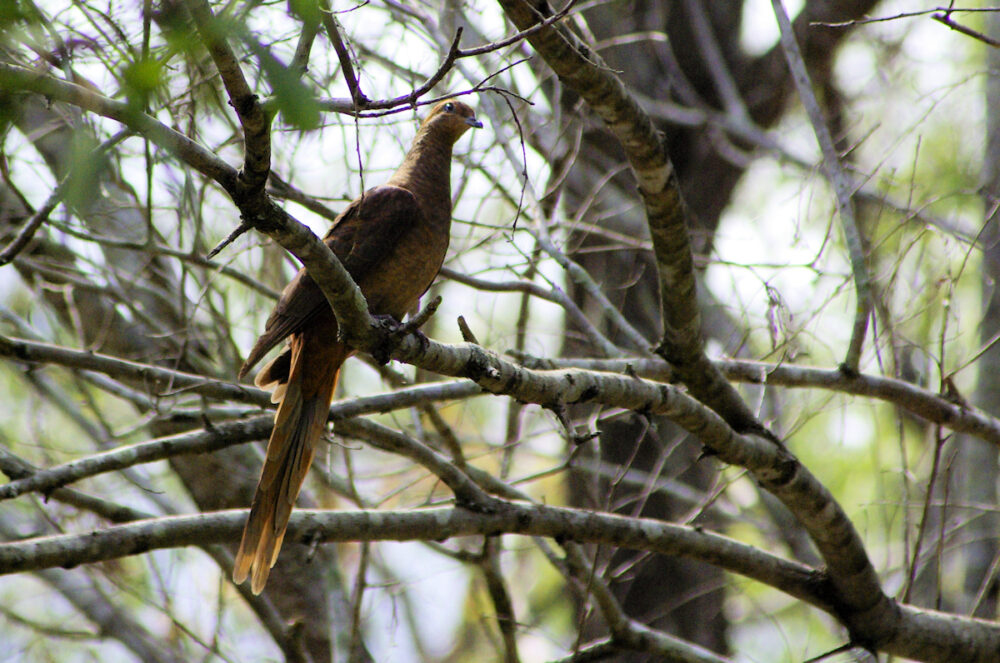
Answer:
240;186;422;377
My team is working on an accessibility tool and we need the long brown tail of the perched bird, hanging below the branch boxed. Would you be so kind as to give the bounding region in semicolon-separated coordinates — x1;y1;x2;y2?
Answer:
233;334;351;594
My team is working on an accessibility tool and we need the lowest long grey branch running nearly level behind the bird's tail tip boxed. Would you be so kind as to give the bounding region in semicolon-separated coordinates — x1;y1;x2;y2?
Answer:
0;504;1000;663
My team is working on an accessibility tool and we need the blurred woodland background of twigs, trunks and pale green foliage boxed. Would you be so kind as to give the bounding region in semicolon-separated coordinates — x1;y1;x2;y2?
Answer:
0;0;1000;662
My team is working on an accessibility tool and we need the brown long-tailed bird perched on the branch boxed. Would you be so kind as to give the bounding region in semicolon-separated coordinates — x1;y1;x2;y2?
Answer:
233;101;482;594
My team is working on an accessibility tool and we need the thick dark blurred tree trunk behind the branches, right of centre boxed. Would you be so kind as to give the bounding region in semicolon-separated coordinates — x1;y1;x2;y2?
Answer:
516;0;876;660
